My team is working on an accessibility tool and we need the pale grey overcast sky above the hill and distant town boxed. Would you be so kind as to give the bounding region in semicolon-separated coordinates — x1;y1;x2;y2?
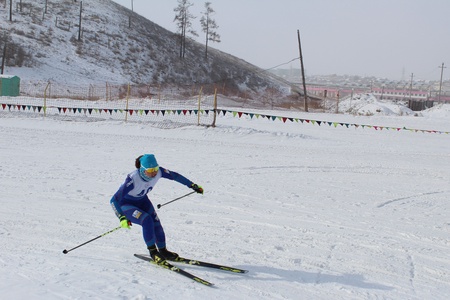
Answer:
110;0;450;80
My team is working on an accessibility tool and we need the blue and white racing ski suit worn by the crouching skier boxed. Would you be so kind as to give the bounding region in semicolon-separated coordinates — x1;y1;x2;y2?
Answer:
110;166;193;249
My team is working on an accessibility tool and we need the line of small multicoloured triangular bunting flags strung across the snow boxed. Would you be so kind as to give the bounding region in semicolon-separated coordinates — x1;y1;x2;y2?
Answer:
1;103;449;134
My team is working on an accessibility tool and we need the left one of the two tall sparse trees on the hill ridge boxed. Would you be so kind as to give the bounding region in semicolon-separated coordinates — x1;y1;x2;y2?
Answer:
173;0;198;58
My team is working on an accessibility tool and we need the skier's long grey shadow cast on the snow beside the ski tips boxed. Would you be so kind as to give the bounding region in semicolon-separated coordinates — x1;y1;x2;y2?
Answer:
230;266;394;290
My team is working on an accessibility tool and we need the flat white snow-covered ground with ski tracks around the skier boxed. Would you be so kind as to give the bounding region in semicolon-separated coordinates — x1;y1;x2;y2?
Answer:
0;102;450;300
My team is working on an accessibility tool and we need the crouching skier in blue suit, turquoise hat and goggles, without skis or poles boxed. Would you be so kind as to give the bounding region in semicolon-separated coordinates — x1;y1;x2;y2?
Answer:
110;154;203;264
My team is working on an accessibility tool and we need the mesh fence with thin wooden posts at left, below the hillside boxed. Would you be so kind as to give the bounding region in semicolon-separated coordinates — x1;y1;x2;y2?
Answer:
0;83;217;127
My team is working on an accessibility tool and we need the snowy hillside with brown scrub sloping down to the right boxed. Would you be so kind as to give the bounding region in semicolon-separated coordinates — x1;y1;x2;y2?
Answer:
0;0;289;95
